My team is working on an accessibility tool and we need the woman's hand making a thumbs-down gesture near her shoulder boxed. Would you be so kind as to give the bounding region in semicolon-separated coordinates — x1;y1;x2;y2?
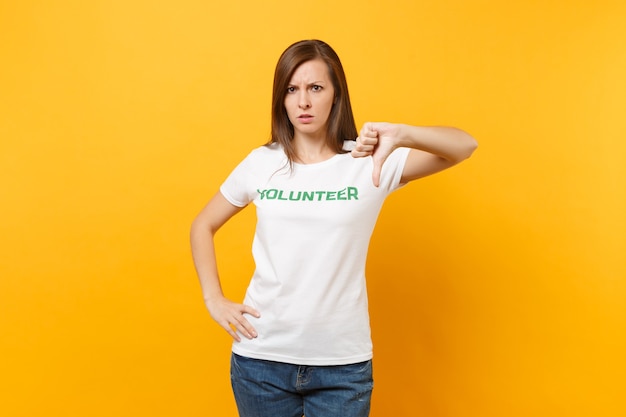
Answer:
352;122;401;187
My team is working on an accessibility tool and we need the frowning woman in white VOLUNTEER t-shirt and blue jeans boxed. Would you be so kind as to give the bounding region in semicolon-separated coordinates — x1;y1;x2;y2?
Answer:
191;40;476;417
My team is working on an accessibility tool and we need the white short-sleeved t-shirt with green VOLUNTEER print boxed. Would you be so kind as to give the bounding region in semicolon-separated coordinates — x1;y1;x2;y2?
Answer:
220;141;409;366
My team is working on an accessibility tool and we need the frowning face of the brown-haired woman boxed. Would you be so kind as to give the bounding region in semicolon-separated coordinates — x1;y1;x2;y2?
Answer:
285;59;335;139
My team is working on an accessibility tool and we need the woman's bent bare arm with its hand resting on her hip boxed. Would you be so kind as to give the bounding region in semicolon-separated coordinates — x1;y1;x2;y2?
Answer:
191;192;260;341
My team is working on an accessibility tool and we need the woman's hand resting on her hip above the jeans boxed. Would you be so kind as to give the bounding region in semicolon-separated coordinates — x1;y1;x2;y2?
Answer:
206;297;261;342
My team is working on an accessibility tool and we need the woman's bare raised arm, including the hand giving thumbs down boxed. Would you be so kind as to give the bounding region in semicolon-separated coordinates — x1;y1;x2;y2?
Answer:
352;122;478;186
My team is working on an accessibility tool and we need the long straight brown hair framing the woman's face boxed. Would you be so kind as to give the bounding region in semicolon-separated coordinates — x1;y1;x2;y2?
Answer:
269;39;358;166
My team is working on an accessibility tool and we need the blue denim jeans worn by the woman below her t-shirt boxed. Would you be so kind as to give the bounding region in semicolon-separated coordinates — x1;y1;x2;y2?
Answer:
230;353;374;417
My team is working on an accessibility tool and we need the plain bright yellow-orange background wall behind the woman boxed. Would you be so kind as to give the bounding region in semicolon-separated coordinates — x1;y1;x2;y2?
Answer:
0;0;626;417
